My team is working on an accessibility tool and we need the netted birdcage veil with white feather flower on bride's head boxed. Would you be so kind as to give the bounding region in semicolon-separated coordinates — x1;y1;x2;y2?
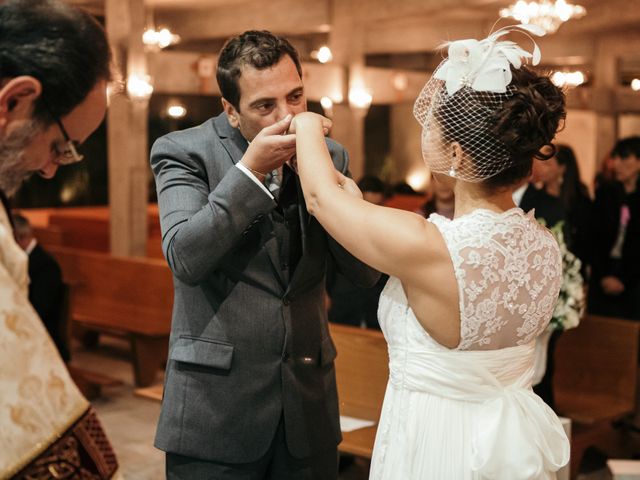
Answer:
413;25;543;182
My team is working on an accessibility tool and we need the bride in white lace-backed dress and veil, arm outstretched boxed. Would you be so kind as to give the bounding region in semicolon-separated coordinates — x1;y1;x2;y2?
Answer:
291;25;569;480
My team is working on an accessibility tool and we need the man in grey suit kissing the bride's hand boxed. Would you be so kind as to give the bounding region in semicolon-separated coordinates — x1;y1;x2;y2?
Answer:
151;31;378;480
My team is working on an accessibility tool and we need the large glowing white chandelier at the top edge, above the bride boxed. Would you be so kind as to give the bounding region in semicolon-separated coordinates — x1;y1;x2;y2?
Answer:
500;0;587;33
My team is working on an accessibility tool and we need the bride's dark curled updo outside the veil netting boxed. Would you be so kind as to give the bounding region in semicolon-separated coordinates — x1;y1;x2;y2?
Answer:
484;66;566;187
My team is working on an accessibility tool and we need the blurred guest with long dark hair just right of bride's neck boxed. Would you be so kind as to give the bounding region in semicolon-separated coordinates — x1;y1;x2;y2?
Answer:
539;145;593;268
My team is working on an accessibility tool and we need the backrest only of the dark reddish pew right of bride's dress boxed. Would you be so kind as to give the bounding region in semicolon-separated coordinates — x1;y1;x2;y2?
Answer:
554;316;640;421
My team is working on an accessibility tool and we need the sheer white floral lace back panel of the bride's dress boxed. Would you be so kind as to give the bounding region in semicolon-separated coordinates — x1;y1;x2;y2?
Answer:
429;208;562;350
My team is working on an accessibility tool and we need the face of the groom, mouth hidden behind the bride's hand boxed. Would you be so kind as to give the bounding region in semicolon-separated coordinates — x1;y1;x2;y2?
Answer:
225;55;307;141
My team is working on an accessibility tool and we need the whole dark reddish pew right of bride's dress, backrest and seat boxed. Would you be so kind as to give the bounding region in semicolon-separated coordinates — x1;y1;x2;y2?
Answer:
553;316;640;478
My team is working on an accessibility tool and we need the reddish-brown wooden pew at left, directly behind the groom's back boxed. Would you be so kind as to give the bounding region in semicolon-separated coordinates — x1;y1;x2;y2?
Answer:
50;248;173;386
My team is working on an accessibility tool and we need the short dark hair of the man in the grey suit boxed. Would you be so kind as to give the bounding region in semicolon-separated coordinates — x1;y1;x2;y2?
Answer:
216;30;302;111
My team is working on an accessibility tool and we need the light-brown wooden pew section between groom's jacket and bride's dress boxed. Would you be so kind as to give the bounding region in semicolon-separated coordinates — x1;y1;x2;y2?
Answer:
330;324;389;458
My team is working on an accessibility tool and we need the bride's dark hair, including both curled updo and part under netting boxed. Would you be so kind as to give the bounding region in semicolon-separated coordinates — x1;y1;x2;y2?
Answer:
432;66;566;188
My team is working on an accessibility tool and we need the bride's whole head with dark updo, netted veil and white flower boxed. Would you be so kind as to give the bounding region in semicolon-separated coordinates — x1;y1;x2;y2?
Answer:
413;25;566;188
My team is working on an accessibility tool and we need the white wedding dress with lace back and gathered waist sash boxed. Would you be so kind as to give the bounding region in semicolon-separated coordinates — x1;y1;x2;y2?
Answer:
370;208;569;480
